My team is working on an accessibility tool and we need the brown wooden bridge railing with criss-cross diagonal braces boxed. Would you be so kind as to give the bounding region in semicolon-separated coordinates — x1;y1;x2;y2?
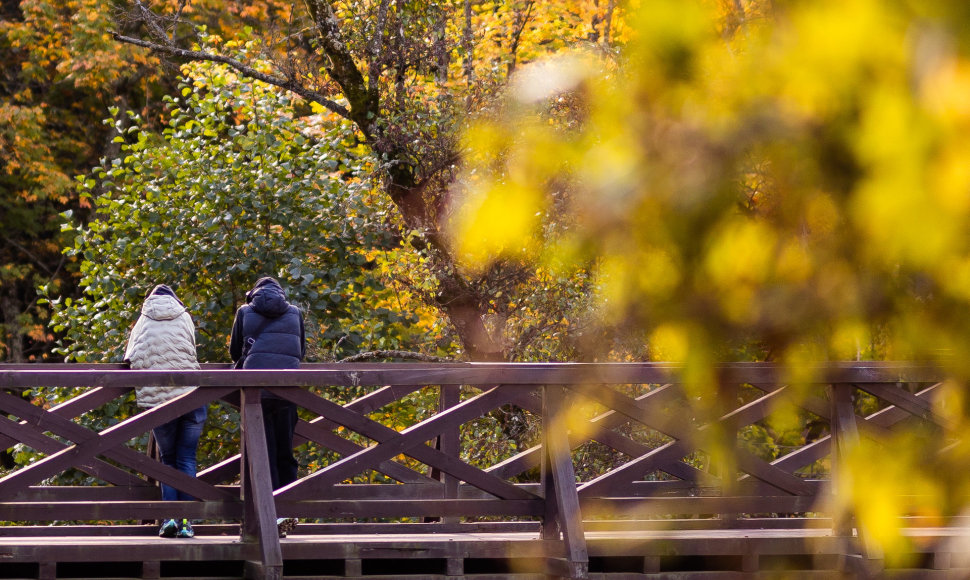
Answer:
0;363;947;578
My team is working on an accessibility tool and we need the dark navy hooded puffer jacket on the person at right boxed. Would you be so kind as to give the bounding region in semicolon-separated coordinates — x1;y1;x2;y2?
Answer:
229;278;306;369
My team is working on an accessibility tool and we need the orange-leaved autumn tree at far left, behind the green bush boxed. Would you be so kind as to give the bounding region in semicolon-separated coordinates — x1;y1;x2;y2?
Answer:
0;0;306;362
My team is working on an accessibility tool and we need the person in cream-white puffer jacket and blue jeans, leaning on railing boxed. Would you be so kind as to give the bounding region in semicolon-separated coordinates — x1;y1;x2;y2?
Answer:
125;284;206;538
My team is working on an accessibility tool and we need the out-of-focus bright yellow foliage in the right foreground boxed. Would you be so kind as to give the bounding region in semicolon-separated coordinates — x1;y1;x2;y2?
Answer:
452;0;970;552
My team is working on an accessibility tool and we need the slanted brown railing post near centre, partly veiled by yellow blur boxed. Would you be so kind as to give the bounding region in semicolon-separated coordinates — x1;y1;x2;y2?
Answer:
541;385;589;578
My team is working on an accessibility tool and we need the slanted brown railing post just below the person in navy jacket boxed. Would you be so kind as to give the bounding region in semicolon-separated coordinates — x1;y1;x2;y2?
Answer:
239;387;283;580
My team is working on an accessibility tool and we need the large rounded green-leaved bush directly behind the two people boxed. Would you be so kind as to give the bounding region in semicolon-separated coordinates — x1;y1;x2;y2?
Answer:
45;63;442;362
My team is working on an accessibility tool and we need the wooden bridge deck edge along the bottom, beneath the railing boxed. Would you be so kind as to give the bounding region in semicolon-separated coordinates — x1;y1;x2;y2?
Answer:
0;525;970;580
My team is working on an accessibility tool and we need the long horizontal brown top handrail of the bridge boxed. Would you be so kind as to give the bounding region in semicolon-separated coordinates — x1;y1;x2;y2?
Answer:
0;361;945;388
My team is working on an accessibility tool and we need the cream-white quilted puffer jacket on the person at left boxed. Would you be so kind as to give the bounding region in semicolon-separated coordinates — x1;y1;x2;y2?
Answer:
125;294;199;408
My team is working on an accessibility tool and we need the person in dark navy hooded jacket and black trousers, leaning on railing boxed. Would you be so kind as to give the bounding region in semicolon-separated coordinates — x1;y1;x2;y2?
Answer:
229;277;306;536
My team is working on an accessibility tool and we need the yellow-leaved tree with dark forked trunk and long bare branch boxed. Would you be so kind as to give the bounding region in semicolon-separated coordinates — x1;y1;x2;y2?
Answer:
115;0;621;360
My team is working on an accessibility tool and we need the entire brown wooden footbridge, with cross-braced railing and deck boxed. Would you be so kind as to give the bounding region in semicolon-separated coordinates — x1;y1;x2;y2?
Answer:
0;363;970;579
